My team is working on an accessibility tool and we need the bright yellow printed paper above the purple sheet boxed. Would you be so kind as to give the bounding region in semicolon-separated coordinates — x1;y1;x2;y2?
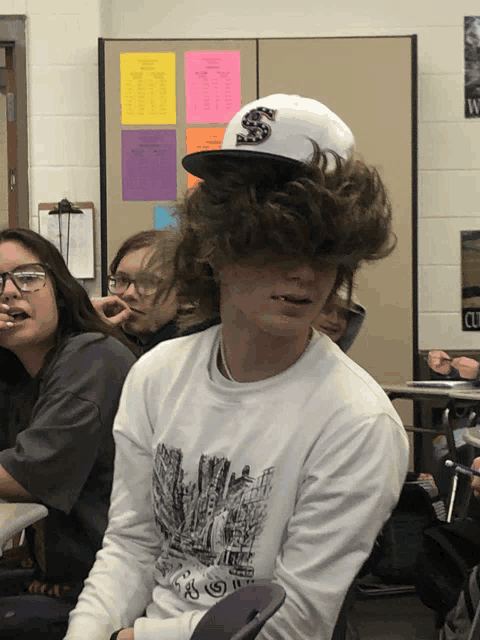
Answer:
120;52;177;124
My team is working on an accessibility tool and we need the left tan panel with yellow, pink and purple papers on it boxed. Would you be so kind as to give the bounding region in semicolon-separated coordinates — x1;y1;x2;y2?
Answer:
100;40;257;274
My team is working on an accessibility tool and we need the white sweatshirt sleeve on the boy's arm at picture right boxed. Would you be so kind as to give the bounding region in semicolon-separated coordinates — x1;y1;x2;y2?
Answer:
258;415;409;640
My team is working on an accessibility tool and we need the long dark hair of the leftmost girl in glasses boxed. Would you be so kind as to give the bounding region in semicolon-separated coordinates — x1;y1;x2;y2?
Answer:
0;229;135;383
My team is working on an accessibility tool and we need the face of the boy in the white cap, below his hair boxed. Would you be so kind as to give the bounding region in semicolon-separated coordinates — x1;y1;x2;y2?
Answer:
219;258;337;338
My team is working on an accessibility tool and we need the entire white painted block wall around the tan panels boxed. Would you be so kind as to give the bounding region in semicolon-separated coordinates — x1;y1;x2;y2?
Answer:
2;0;480;338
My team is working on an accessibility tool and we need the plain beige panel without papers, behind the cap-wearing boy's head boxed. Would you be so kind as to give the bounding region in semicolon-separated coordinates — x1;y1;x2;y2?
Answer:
259;37;413;398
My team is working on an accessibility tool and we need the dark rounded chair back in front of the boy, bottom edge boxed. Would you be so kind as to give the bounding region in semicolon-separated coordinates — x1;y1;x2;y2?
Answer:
190;580;286;640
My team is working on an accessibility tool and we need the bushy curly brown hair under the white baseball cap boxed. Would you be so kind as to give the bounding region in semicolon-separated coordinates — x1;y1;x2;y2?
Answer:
174;141;396;316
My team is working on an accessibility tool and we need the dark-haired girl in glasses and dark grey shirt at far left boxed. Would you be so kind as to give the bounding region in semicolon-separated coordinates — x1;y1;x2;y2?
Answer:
0;229;135;638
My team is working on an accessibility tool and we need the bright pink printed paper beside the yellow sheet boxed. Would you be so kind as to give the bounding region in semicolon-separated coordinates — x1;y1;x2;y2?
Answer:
185;51;242;124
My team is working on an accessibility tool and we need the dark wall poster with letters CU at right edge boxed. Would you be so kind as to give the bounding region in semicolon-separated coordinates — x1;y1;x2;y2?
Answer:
461;231;480;331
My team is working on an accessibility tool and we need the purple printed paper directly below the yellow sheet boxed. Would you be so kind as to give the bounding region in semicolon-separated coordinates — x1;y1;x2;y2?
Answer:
122;129;177;201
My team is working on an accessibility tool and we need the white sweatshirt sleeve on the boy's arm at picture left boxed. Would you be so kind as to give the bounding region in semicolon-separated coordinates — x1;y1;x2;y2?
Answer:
62;367;160;640
